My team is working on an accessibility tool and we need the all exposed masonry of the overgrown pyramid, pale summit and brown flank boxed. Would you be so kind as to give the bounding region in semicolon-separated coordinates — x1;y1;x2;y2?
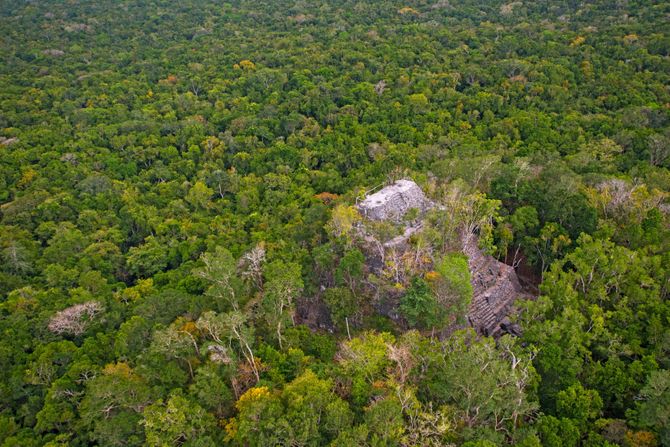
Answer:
357;179;530;336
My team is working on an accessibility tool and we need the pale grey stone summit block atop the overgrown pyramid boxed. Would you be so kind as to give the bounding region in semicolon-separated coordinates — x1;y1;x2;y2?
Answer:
358;179;430;222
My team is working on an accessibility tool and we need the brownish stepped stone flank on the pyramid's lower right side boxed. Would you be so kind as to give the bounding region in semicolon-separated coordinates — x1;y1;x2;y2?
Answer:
463;236;529;336
